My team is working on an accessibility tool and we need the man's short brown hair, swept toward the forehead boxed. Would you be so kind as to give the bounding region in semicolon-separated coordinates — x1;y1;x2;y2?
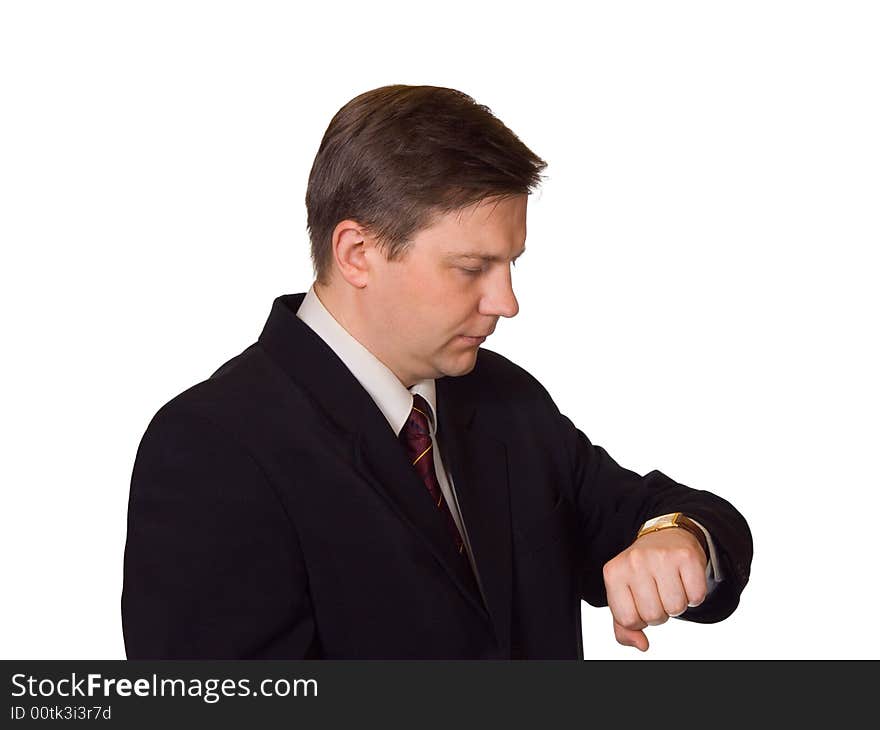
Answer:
306;84;547;284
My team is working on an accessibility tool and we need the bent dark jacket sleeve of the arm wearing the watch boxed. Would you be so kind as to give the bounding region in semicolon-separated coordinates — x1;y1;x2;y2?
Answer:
553;406;752;623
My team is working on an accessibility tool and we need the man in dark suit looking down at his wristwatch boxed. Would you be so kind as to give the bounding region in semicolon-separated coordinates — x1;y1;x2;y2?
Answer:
122;86;752;659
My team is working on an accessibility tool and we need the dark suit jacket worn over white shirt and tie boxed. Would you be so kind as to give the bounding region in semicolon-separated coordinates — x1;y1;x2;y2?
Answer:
122;294;752;659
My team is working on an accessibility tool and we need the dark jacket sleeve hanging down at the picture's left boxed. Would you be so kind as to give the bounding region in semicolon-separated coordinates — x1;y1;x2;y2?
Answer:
122;402;317;659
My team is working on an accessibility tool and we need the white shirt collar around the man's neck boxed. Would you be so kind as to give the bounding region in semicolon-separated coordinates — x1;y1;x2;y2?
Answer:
296;284;439;436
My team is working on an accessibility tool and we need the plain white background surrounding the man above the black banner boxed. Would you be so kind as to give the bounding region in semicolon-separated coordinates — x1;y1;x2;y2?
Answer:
0;0;880;660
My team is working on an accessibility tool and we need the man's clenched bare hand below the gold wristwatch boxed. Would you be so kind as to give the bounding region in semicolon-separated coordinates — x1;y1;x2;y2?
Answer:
602;527;707;651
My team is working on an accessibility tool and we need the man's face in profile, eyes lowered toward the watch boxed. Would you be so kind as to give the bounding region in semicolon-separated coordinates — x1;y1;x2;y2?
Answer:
367;195;528;387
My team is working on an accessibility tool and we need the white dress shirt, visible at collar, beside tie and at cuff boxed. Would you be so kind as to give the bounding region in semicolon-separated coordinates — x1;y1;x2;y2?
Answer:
296;285;720;612
